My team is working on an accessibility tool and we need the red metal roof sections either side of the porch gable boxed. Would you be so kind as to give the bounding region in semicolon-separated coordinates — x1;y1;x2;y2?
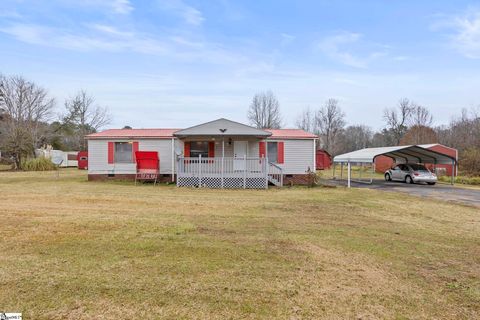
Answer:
86;129;317;139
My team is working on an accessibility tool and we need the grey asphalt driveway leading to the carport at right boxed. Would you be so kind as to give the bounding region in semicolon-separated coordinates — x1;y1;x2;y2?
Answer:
332;180;480;207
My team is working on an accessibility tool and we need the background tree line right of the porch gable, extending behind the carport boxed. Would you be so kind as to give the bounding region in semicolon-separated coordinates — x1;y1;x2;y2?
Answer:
248;91;480;175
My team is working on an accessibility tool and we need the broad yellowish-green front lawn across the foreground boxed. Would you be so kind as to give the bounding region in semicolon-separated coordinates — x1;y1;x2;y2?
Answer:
0;170;480;319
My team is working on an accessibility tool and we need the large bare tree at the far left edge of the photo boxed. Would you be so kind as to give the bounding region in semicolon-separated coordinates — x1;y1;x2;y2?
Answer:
0;76;55;168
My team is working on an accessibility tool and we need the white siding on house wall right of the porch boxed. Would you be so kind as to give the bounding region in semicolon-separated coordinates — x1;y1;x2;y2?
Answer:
269;139;315;174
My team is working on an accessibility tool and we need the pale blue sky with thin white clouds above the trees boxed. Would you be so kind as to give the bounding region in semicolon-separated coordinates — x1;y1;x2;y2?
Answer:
0;0;480;129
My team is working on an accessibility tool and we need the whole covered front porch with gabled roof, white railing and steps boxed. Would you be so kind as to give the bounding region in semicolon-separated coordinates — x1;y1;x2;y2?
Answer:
174;119;283;189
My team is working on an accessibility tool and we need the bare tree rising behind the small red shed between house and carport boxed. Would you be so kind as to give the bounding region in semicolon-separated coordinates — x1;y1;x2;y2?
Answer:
315;99;345;155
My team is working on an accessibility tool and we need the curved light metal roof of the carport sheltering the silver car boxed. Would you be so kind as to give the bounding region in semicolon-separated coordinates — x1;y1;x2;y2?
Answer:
333;145;455;164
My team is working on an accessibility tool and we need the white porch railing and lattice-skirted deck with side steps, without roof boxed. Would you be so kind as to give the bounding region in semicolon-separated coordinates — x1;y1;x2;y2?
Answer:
177;155;283;189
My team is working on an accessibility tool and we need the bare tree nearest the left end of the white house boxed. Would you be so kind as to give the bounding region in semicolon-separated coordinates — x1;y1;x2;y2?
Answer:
64;90;111;150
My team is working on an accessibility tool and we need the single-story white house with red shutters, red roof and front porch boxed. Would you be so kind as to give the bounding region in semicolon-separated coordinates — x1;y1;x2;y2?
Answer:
86;118;317;188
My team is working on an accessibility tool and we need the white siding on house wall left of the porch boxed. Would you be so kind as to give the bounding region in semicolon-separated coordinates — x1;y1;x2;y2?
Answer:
88;139;172;174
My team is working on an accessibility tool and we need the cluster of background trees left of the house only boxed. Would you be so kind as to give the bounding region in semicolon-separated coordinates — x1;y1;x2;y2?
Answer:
0;75;111;168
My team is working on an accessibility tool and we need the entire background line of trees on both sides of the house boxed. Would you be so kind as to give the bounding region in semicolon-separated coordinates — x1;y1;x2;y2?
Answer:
0;75;480;174
